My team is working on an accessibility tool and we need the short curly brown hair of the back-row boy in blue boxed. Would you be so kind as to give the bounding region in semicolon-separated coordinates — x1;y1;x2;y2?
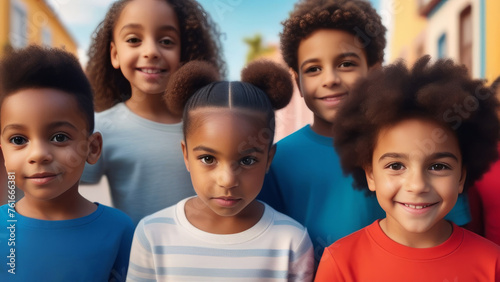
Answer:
280;0;387;72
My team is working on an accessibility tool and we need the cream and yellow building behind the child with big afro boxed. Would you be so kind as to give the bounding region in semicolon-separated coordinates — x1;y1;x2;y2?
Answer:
386;0;500;82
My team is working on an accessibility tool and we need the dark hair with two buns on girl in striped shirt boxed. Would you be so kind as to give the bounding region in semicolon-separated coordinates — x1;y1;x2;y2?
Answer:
164;60;293;147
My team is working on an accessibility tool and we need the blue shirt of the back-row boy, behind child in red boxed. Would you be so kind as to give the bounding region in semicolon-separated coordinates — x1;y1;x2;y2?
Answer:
259;125;470;261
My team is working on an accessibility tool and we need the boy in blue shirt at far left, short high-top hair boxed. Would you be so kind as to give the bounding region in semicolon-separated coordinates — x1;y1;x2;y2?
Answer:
0;46;134;281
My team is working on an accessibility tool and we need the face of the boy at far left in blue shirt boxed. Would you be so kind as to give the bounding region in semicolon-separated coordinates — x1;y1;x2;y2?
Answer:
0;88;102;201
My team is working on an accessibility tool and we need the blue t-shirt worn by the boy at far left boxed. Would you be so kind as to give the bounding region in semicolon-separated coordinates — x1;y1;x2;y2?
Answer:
0;204;134;282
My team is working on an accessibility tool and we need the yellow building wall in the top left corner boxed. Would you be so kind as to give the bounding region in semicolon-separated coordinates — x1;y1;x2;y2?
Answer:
0;0;78;56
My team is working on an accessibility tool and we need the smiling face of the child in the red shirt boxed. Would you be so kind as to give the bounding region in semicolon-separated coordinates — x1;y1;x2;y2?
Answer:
365;119;465;245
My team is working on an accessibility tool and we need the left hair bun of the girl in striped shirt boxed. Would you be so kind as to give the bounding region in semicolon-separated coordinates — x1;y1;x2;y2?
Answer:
163;60;220;116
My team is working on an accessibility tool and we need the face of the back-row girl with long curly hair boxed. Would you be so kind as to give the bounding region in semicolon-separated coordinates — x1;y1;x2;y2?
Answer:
111;0;181;95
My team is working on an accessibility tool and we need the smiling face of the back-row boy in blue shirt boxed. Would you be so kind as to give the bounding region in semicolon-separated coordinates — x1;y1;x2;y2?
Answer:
297;29;368;136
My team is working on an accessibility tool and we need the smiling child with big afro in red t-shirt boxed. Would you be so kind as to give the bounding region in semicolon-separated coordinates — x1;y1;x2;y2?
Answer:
316;56;500;281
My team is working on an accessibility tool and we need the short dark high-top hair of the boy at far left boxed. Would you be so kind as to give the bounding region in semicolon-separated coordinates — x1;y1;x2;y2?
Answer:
0;45;94;134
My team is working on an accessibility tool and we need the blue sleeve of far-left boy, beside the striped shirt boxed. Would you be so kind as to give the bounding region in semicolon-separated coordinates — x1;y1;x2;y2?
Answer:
109;214;134;281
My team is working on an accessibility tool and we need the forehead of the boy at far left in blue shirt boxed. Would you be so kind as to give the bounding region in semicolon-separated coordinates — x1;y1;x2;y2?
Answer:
0;88;87;129
